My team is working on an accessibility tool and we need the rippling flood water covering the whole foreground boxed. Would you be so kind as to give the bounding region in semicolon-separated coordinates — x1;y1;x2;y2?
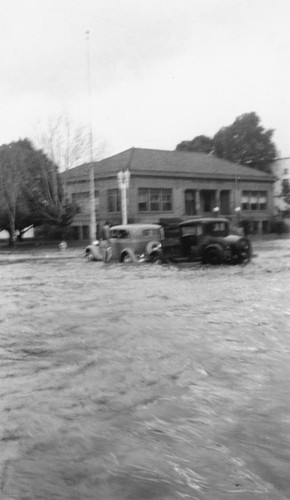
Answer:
0;240;290;500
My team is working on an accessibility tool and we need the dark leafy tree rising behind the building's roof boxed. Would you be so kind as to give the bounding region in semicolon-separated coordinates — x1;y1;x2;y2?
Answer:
176;112;277;171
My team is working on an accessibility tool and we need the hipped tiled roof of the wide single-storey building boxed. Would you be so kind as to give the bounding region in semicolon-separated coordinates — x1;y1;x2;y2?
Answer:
69;148;273;181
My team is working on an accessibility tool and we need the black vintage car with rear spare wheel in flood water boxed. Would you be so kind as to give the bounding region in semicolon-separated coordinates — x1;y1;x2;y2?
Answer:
151;218;251;265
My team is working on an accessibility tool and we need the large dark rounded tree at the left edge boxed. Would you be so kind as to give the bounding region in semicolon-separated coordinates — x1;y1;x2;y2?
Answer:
0;139;76;243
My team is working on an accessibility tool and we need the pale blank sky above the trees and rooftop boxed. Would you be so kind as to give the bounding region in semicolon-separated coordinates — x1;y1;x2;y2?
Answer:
0;0;290;156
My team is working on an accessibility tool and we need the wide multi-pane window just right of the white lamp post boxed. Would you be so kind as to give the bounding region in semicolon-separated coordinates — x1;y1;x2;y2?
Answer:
138;188;172;212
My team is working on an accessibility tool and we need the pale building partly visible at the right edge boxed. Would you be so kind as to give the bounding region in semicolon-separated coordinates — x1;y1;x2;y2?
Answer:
271;158;290;214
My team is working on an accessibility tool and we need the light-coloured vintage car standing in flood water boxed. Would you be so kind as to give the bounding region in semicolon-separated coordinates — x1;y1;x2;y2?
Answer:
85;224;164;263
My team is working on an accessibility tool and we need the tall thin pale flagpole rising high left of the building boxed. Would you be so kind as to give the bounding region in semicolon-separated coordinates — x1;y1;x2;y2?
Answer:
86;31;96;241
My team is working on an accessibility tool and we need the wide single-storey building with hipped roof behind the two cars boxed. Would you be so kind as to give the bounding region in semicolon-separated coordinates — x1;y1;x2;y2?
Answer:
65;148;274;239
